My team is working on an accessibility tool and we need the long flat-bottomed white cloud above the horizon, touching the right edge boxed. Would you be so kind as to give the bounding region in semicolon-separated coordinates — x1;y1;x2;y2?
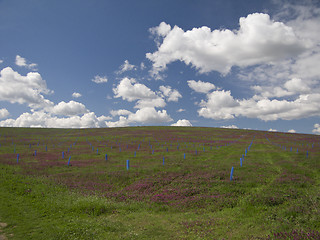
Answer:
198;90;320;121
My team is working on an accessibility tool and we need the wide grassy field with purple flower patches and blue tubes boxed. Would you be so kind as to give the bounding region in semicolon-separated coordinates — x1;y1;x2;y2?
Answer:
0;127;320;239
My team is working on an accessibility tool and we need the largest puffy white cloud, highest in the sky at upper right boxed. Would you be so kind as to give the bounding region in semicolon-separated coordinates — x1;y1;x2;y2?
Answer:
146;13;309;74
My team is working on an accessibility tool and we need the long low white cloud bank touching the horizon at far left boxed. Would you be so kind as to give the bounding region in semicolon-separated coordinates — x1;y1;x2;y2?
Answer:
0;111;110;128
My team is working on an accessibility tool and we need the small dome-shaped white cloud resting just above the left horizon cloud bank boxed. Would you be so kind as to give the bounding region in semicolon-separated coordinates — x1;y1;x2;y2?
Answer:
51;101;89;116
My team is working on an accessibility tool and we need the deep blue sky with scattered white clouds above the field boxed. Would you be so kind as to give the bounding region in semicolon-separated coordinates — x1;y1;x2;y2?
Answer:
0;0;320;134
